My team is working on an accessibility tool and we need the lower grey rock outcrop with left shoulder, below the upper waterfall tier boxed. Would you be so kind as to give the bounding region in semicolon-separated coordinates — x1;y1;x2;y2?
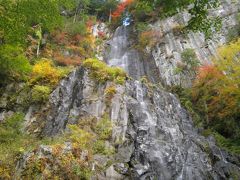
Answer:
21;70;240;179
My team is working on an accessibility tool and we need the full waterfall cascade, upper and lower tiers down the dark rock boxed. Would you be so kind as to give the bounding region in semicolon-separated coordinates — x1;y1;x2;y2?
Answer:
104;27;239;180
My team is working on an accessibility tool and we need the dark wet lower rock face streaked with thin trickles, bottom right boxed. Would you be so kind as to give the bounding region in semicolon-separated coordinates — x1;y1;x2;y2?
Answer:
124;81;239;179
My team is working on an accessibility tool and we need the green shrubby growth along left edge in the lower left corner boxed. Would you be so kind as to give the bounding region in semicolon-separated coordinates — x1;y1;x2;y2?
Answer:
0;113;37;179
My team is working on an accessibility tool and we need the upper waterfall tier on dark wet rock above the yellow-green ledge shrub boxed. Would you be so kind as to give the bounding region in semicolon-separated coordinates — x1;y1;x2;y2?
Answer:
105;26;161;83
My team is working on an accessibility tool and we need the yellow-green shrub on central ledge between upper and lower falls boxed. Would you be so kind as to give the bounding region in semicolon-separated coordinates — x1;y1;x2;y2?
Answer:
83;58;127;84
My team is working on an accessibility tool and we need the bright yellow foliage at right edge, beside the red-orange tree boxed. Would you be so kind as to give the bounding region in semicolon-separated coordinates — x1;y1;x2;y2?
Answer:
211;38;240;117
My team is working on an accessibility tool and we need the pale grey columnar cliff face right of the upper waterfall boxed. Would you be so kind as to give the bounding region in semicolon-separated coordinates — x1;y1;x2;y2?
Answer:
149;0;240;86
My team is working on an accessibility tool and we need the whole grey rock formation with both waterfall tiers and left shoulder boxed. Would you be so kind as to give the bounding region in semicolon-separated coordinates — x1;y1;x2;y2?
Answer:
18;23;240;180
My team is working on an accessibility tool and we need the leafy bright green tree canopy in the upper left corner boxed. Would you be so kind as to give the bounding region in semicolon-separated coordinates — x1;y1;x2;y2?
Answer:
0;0;70;45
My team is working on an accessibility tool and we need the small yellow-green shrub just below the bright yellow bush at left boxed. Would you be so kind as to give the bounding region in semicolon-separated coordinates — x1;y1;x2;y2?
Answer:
32;85;51;103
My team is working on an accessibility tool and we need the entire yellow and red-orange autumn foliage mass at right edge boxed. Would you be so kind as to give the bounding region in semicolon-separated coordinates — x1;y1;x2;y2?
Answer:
192;40;240;137
